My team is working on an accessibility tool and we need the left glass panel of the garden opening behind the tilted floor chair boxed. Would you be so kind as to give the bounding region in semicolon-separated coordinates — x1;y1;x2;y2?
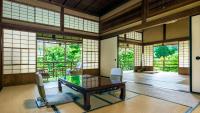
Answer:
37;40;66;77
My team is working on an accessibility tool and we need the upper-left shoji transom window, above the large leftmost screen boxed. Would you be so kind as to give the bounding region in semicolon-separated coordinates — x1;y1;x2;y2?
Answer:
3;0;60;26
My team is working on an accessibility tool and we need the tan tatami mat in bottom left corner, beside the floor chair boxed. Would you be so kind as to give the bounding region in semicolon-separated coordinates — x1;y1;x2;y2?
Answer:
0;84;54;113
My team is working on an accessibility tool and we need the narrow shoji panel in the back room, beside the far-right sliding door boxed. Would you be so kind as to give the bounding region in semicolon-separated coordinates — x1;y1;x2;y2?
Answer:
179;41;190;67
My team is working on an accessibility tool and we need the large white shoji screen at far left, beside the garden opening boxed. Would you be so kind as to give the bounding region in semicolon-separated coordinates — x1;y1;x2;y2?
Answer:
3;29;36;74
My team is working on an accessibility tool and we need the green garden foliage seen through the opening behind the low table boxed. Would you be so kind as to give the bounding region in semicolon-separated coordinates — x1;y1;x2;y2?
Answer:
37;43;82;79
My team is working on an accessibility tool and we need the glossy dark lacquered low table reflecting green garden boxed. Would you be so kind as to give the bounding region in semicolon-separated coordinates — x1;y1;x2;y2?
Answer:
58;75;126;110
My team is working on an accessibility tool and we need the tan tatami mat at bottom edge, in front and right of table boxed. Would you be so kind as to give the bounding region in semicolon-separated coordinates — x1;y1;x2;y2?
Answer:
90;96;189;113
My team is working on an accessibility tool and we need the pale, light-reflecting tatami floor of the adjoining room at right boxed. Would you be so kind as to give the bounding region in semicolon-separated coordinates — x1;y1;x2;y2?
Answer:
123;71;189;92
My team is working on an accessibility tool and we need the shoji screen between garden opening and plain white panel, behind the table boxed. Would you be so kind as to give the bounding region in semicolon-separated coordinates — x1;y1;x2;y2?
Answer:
83;39;99;69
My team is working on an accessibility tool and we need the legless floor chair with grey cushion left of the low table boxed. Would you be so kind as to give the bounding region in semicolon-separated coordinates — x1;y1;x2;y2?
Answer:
36;72;73;107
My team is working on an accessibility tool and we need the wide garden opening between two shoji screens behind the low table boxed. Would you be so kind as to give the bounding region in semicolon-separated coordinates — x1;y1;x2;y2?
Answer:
37;33;82;82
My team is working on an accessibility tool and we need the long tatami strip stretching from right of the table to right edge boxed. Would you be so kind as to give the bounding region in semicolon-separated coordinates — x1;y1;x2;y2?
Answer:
126;82;200;107
